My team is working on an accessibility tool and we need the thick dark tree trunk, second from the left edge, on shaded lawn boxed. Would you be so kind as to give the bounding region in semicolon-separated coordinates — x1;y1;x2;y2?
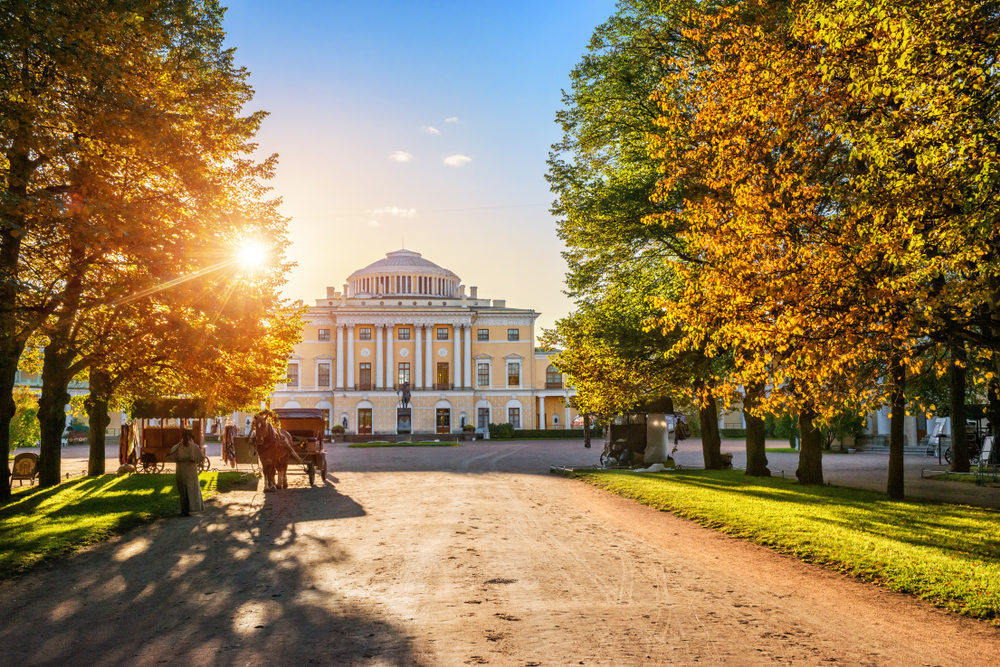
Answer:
38;338;74;486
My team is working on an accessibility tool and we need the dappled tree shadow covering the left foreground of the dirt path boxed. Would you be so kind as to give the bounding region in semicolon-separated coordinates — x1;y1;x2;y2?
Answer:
0;476;420;665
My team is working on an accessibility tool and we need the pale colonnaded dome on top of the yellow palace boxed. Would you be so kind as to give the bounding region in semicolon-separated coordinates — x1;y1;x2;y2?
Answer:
347;248;461;297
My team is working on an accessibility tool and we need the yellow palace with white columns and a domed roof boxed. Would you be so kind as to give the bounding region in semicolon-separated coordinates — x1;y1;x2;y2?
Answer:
271;249;577;435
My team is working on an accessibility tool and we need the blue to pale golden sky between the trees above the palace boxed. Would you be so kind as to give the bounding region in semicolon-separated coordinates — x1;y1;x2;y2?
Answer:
225;0;615;327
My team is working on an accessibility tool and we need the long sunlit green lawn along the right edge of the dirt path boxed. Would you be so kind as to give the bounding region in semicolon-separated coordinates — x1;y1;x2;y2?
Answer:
575;470;1000;625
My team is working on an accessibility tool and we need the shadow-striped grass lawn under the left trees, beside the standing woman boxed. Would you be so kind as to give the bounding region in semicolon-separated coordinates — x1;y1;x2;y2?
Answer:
0;472;246;580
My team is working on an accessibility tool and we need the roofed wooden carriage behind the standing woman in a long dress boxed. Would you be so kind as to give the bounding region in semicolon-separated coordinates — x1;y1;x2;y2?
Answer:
132;398;212;473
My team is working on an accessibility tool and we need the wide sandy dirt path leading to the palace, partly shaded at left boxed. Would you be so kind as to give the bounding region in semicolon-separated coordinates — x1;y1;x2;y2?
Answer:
0;443;1000;667
